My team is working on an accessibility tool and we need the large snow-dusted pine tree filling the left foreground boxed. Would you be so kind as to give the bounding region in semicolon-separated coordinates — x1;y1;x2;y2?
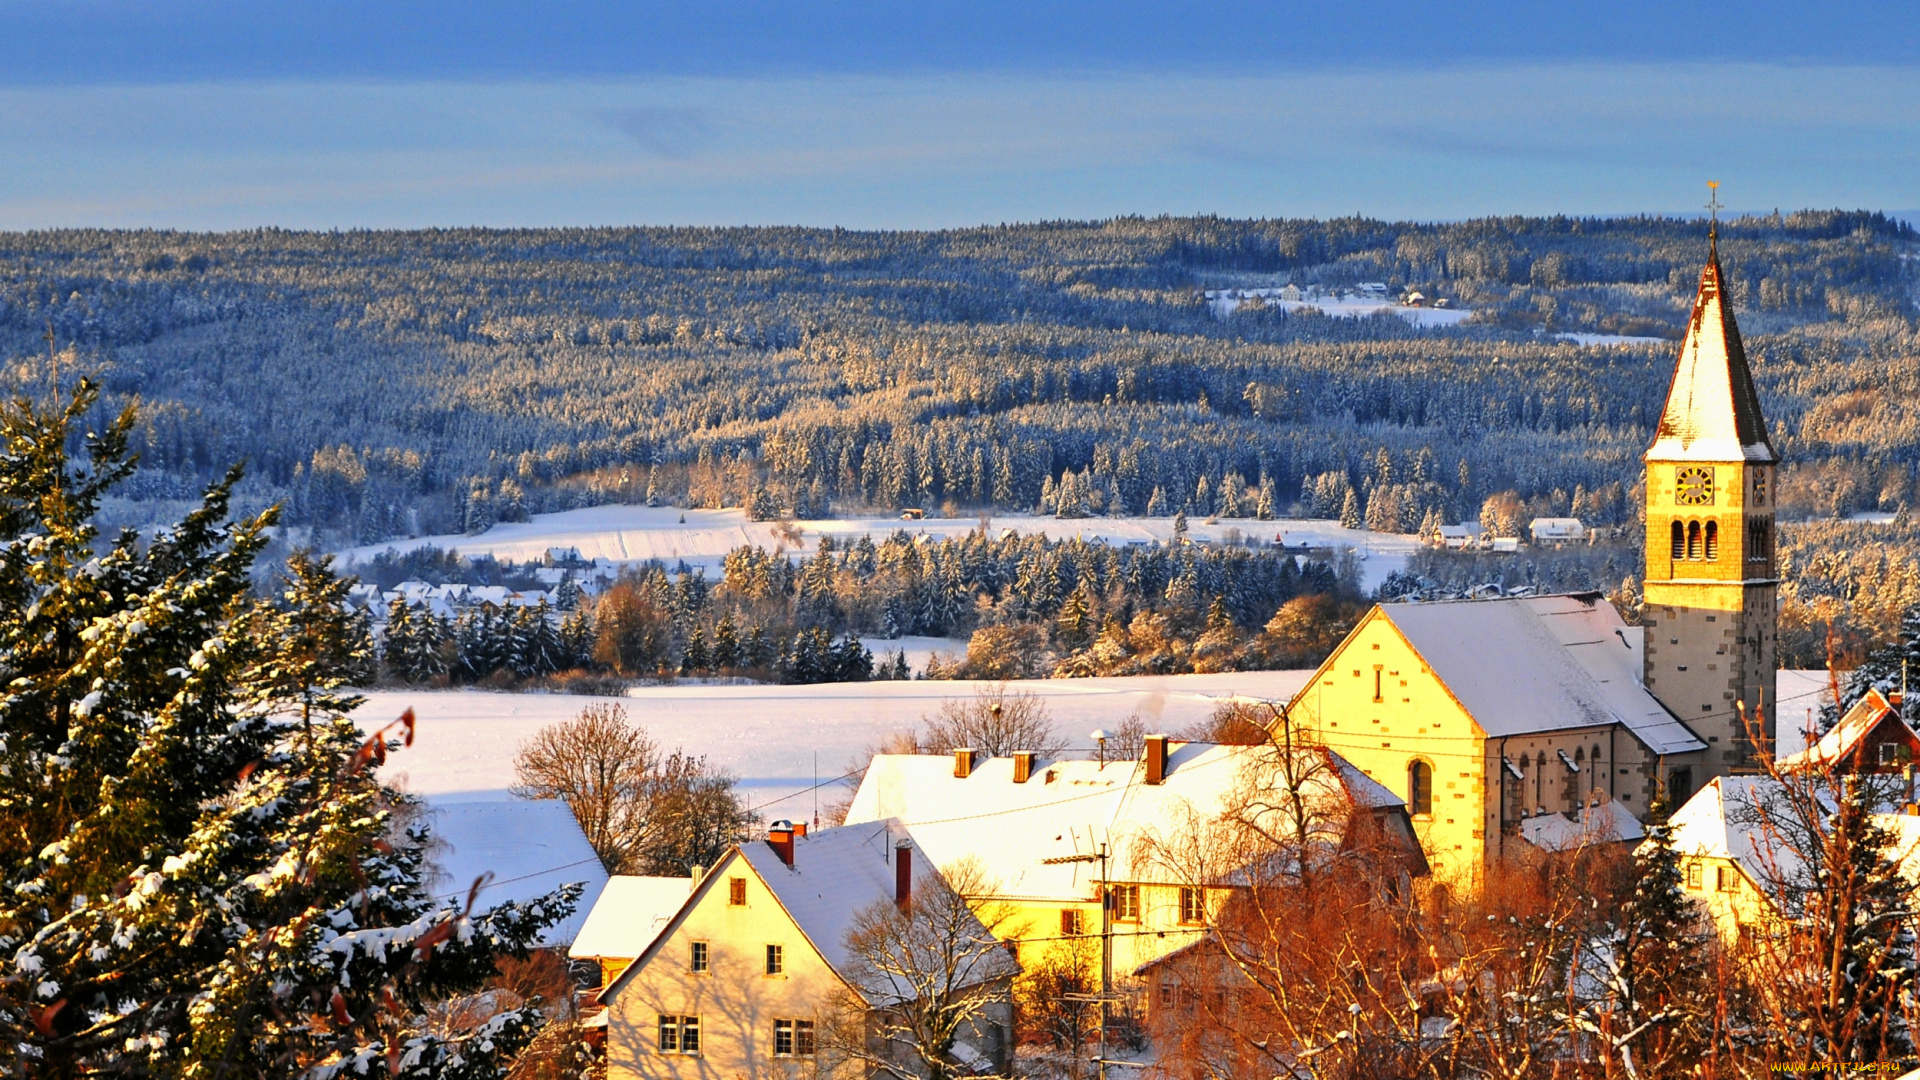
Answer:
0;380;578;1080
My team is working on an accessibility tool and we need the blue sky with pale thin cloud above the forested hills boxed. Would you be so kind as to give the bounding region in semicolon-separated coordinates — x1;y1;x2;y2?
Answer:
0;0;1920;229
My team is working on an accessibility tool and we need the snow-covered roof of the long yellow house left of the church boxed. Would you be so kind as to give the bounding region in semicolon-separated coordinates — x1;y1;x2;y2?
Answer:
847;742;1402;899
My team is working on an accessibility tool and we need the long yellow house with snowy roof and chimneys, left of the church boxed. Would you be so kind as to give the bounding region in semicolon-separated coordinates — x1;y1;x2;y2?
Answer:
847;736;1427;970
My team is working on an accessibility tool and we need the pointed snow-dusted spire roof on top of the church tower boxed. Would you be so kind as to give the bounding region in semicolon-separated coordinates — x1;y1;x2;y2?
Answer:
1647;239;1778;463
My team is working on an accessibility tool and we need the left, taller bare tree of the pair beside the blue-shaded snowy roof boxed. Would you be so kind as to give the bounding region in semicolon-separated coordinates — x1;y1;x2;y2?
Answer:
513;701;660;874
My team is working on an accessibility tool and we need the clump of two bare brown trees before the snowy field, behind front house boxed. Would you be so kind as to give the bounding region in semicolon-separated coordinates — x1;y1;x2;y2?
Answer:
513;701;758;874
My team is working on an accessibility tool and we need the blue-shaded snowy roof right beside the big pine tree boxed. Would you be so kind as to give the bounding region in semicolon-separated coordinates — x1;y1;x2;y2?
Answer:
426;796;607;945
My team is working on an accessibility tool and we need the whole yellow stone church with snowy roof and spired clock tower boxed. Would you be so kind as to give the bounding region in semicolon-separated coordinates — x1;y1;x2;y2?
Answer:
1286;236;1780;878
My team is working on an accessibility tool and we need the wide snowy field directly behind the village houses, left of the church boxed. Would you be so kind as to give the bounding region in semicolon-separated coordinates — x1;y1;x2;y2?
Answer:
361;671;1313;817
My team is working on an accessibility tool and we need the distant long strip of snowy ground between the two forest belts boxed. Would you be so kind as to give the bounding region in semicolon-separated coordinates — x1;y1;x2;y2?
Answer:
342;505;1419;588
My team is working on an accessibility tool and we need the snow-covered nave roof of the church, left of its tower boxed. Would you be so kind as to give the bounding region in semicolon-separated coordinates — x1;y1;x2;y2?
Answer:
1375;592;1707;753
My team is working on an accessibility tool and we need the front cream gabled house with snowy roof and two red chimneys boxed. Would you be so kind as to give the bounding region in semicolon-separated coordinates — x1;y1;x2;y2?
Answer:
601;821;1018;1080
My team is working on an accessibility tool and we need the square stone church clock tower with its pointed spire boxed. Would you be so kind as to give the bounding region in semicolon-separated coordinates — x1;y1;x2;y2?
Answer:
1644;214;1780;780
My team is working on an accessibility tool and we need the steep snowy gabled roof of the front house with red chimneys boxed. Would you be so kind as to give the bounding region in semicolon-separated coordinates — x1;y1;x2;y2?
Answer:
601;821;1018;1005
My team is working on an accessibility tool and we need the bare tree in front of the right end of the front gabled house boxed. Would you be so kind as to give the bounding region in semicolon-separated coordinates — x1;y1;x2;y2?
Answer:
822;859;1021;1080
